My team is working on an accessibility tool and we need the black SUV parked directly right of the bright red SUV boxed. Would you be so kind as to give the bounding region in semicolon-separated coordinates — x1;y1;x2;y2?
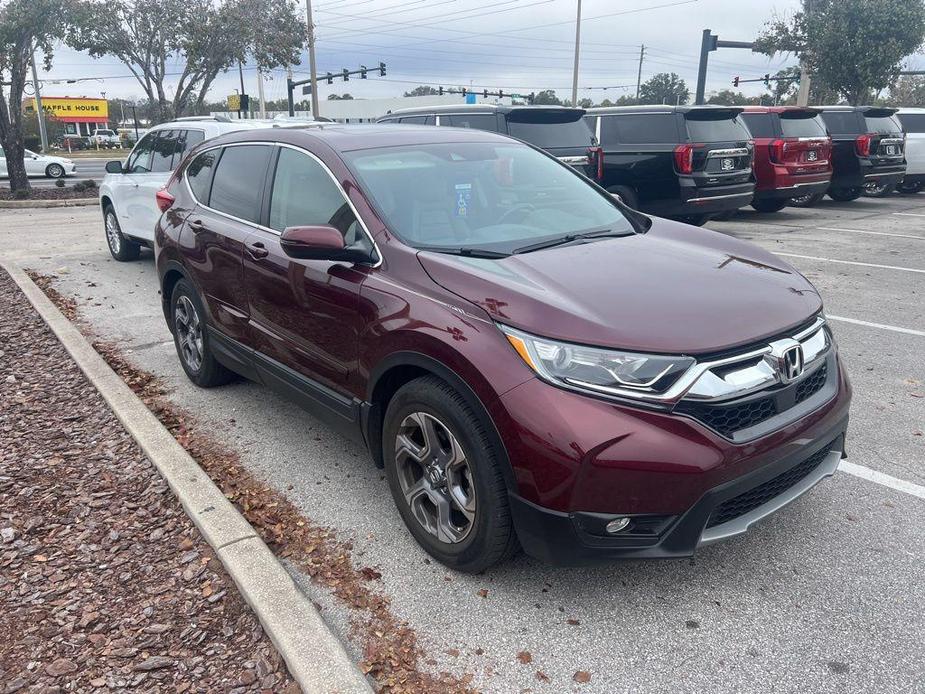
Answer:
802;106;906;204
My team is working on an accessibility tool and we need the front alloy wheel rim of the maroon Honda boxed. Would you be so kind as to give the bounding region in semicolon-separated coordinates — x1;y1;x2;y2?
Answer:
395;412;476;544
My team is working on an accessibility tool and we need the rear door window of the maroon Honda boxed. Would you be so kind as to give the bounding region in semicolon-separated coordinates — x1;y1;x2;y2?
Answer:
209;145;270;224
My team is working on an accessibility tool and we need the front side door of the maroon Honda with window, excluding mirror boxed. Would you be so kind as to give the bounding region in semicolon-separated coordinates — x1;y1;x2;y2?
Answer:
244;146;371;409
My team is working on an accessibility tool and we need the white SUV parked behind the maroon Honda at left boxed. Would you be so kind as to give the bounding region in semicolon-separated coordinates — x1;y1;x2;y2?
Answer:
100;116;272;261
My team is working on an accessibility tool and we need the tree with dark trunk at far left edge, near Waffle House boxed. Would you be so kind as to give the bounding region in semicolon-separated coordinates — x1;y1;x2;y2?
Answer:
0;0;73;192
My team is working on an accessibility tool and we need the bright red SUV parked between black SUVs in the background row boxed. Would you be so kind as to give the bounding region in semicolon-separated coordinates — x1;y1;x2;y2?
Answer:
739;106;832;212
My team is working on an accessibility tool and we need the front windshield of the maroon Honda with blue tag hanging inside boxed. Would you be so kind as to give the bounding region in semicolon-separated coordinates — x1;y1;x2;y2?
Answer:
344;143;634;253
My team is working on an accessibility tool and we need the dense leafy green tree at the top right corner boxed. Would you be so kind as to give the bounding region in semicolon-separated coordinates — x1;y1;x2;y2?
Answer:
756;0;925;105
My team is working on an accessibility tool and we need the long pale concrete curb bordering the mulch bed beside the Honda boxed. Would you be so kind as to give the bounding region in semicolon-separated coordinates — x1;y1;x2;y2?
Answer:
0;261;372;694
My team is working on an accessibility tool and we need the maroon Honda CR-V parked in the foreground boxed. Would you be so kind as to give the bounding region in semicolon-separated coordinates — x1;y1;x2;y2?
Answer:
156;124;851;571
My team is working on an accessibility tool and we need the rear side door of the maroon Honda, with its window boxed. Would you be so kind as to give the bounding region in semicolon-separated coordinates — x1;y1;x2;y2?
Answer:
179;144;273;349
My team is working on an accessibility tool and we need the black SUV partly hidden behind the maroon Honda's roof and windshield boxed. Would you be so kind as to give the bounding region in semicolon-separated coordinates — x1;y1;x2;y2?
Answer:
376;104;603;181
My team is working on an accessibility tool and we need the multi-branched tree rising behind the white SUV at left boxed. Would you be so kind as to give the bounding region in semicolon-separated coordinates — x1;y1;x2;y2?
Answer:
68;0;307;121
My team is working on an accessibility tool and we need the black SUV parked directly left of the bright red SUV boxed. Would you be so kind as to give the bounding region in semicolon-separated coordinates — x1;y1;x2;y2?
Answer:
585;106;755;225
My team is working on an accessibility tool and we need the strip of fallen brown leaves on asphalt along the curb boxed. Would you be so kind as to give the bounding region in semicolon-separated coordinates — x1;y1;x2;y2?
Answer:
23;272;484;694
